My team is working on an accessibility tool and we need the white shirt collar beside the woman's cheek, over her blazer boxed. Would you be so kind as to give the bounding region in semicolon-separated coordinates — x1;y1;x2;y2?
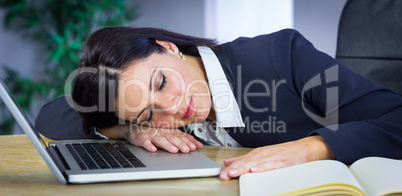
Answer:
198;46;244;127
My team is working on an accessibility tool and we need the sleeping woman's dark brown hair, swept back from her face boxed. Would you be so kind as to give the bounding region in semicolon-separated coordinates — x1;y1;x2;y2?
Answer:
72;27;215;134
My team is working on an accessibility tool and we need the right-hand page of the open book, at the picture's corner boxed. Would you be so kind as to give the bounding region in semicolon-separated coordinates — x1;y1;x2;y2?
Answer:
350;157;402;195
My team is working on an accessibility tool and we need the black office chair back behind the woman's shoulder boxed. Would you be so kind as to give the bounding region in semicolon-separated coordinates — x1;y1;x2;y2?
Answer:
336;0;402;95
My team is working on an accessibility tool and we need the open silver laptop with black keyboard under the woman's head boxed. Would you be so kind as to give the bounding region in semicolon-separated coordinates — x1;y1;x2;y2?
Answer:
0;78;221;184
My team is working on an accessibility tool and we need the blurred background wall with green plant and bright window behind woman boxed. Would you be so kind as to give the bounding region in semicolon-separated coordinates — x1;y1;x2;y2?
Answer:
0;0;346;135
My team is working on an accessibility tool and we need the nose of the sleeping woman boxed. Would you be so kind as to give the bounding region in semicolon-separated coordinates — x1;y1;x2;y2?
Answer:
155;94;180;115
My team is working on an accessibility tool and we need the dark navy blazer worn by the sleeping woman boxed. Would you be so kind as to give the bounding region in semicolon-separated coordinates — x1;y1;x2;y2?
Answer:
35;29;402;164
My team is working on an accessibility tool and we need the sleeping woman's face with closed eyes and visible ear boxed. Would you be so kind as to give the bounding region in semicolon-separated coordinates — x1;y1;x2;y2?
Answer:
116;41;211;127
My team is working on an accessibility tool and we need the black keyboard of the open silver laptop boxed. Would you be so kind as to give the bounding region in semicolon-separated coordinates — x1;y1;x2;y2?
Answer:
66;142;145;170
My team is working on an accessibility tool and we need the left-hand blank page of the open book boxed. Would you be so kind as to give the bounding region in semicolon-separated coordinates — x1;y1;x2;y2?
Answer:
239;160;362;196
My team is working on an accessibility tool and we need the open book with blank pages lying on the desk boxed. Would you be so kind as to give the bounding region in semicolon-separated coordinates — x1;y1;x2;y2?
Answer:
239;157;402;196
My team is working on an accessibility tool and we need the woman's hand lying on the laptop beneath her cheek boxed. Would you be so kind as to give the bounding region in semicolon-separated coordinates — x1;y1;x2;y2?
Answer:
98;125;203;153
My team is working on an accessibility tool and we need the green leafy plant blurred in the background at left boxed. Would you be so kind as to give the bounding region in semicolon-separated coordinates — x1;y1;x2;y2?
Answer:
0;0;138;134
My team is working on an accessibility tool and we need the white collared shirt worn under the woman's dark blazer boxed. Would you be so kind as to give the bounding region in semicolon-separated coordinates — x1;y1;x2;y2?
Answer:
187;46;244;147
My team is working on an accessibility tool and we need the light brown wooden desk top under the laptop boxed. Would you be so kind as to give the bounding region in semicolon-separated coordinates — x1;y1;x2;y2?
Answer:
0;135;251;196
